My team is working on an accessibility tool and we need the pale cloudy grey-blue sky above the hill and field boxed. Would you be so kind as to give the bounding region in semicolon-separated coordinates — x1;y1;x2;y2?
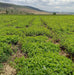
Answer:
0;0;74;12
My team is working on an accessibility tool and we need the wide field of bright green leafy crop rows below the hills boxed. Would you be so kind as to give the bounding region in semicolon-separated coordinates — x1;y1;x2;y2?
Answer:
0;15;74;75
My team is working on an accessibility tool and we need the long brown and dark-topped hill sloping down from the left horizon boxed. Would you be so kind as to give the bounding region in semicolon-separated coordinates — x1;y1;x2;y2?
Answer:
0;2;50;14
